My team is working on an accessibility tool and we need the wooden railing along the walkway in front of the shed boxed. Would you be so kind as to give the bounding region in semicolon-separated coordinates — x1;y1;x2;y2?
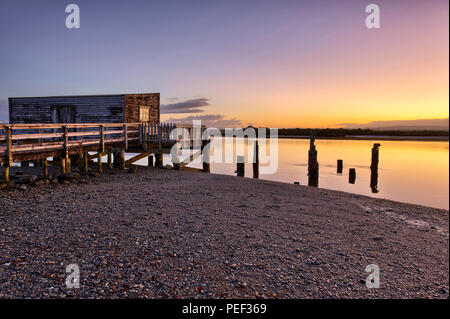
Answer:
0;123;204;161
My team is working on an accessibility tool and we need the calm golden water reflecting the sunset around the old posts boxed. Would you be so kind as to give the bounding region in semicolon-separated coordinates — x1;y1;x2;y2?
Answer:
128;138;449;209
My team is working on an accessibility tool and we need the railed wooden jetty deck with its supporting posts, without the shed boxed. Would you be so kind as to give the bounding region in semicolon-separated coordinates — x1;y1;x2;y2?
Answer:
0;123;209;181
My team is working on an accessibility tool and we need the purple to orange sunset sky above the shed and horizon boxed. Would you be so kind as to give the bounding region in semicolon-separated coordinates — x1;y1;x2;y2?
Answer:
0;0;449;127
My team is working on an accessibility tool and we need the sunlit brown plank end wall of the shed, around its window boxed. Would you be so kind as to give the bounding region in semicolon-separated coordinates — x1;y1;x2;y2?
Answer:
124;93;160;123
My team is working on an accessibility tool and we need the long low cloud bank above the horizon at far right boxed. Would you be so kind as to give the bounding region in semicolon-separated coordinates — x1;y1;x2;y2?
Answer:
336;118;449;130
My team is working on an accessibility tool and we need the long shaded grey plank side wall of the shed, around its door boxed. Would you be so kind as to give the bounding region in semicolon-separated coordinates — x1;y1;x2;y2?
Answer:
9;95;124;124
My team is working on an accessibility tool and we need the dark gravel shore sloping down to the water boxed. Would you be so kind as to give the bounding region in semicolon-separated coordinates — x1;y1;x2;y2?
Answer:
0;167;449;298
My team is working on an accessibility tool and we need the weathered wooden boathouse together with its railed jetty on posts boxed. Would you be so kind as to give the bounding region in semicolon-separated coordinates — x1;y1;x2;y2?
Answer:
0;93;209;182
